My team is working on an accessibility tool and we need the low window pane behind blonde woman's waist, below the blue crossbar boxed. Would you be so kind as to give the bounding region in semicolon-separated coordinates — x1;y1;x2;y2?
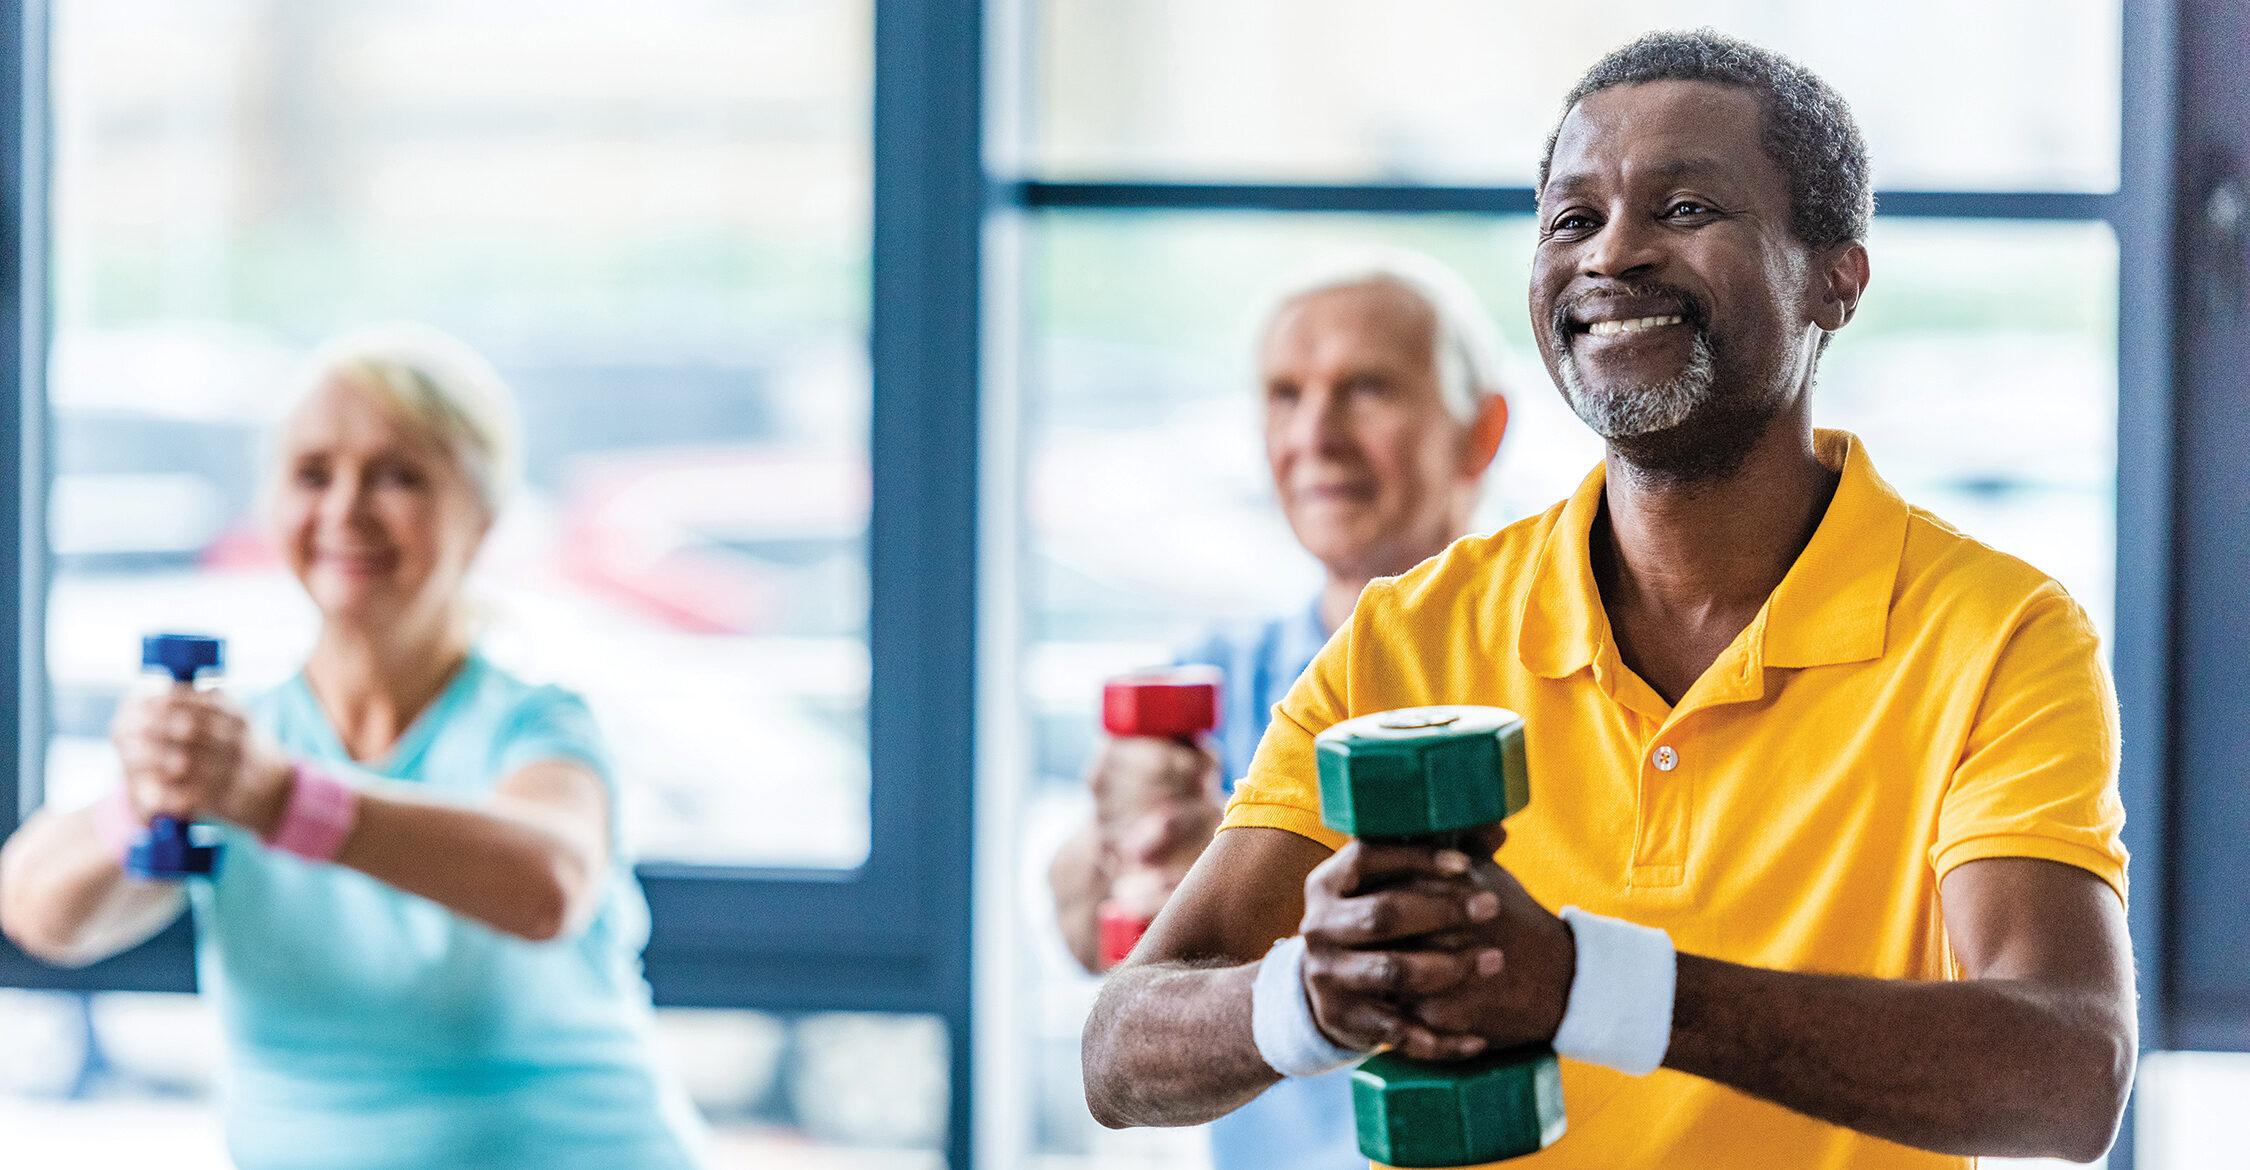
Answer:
0;990;950;1170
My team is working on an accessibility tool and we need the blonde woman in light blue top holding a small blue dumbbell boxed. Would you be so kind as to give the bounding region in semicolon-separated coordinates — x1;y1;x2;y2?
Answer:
0;329;700;1170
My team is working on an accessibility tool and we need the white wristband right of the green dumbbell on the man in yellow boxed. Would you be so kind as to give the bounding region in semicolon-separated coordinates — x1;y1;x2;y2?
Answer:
1555;907;1679;1076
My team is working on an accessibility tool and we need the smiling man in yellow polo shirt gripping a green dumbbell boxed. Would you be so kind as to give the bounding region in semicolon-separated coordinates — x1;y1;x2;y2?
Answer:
1085;34;2135;1168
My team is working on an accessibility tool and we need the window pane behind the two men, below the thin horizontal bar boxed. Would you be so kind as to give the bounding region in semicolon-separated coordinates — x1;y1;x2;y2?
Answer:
988;212;2117;1166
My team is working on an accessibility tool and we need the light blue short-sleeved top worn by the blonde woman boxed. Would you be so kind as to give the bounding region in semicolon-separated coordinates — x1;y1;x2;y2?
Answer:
191;655;702;1170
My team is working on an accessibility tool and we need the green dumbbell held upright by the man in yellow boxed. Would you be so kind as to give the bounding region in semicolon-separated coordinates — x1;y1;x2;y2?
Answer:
1314;707;1564;1166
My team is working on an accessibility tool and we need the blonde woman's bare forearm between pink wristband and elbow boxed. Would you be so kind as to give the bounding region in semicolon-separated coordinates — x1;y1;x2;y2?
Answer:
335;785;605;941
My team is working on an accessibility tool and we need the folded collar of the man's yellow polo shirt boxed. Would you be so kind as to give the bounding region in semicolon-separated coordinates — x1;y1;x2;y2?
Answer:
1517;430;1908;677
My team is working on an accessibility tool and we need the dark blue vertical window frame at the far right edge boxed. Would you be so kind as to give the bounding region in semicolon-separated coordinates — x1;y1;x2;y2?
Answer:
2135;0;2250;1051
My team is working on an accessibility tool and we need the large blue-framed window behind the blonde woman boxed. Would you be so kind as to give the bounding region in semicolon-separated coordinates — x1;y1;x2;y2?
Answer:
0;0;977;1168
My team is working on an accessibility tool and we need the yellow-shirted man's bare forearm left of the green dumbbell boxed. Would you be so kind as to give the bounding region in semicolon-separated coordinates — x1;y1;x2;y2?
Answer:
1082;963;1280;1130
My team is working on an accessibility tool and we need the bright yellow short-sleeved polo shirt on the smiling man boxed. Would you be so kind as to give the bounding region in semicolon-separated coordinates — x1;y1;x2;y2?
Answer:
1224;432;2126;1170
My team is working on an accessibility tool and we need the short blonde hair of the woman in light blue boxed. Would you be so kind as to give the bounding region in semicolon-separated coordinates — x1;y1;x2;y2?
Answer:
293;324;522;515
